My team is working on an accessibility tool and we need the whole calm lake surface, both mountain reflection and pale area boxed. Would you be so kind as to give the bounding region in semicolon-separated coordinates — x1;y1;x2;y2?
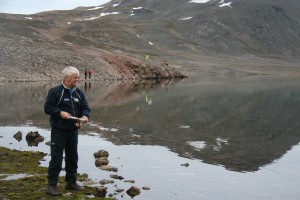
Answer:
0;76;300;200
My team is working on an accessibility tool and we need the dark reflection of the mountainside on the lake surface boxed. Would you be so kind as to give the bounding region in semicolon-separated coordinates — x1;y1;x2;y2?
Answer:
0;77;300;172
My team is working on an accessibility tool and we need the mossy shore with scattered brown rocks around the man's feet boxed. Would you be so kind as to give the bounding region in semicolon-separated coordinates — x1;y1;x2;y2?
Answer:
0;131;150;199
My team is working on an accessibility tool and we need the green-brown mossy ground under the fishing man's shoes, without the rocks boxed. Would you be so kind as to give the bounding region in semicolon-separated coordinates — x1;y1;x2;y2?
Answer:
0;147;111;199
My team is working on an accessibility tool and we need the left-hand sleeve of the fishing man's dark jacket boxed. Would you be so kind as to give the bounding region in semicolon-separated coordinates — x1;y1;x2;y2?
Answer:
44;88;61;117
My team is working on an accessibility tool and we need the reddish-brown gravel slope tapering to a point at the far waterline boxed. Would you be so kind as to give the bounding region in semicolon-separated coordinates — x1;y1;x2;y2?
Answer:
0;34;185;81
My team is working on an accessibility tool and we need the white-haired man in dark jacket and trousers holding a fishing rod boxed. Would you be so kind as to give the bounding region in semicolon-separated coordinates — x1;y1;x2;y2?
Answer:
44;67;90;196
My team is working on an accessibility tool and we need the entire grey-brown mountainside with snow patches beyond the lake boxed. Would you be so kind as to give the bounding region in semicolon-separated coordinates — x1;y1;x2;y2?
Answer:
0;0;300;80
